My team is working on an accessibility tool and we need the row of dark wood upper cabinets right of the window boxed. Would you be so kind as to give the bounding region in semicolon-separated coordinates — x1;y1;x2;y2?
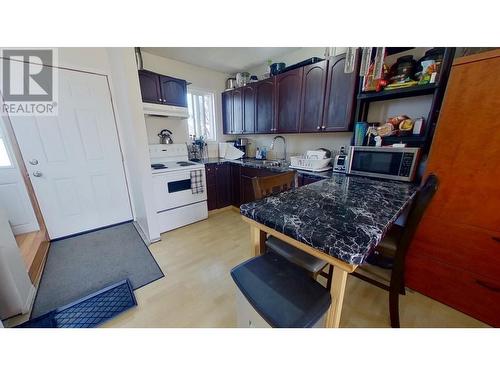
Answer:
222;54;359;134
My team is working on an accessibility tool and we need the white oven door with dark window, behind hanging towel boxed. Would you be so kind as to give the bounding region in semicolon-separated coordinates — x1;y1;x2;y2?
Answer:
153;168;207;212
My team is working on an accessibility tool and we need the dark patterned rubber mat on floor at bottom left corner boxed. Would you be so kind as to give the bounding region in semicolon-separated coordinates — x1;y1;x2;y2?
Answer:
17;279;137;328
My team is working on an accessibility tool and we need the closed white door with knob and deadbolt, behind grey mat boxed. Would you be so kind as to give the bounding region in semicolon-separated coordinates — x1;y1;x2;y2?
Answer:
11;65;132;239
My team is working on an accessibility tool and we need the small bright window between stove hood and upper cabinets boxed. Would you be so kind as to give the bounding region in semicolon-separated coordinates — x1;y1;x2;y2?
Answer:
187;88;216;141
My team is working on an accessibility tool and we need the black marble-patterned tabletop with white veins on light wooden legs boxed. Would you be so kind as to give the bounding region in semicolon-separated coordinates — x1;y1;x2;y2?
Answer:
240;174;418;265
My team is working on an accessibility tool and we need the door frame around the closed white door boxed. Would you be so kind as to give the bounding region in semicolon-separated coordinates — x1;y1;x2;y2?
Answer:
0;57;136;241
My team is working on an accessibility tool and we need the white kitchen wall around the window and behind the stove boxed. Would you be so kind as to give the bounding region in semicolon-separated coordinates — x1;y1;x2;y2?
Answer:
142;52;228;156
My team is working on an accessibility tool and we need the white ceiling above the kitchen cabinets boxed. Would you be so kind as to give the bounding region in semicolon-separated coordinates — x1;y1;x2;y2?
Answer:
141;47;299;73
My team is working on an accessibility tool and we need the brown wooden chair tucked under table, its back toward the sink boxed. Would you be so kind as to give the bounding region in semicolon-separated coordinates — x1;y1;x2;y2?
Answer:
252;172;333;287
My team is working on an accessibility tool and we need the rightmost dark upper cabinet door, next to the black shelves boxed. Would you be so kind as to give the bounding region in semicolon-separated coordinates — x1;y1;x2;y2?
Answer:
321;54;358;131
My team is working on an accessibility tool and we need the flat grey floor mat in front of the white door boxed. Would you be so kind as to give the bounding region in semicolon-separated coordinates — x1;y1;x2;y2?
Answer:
31;223;164;318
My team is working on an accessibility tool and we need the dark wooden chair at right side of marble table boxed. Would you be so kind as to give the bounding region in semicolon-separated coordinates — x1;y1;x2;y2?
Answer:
351;174;439;328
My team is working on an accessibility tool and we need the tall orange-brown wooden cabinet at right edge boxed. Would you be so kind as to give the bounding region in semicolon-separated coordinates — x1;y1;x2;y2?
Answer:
406;49;500;327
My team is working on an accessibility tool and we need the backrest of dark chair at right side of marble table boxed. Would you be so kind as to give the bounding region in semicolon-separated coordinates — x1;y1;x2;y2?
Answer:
398;174;439;257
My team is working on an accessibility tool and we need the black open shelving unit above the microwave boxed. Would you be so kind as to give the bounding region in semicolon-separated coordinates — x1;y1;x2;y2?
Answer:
356;47;455;153
